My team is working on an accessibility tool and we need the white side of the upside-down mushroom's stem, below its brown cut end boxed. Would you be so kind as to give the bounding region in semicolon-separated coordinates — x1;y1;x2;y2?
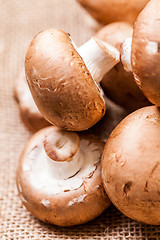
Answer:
46;147;84;180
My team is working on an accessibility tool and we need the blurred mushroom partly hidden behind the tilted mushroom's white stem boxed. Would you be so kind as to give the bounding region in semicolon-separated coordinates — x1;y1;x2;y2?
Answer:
95;22;150;111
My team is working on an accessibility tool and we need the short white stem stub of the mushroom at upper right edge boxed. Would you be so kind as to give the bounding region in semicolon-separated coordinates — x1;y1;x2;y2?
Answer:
121;37;132;72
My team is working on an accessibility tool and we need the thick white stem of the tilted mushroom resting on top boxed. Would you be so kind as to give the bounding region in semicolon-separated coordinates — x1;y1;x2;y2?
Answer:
77;37;120;83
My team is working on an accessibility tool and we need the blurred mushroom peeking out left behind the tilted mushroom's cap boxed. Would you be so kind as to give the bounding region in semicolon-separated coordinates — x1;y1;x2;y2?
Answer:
14;69;50;132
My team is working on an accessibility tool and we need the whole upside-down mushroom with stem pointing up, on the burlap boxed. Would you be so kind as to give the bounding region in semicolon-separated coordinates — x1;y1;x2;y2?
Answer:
17;126;110;226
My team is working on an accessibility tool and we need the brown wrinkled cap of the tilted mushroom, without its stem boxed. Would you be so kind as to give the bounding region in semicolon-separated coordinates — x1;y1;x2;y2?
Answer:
25;29;105;131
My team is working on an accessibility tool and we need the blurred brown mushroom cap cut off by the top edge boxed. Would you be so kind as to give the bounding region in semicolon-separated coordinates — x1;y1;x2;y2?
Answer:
77;0;149;24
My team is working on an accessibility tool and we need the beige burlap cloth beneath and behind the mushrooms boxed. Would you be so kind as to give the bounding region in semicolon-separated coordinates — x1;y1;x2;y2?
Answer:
0;0;160;240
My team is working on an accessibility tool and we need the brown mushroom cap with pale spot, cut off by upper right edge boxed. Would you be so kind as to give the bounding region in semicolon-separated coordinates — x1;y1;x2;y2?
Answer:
131;0;160;106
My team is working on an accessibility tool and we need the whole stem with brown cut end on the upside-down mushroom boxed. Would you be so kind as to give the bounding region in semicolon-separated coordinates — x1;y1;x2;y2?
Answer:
44;129;84;179
